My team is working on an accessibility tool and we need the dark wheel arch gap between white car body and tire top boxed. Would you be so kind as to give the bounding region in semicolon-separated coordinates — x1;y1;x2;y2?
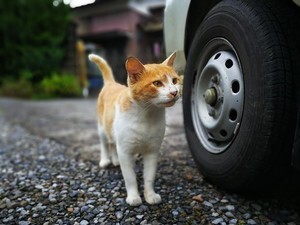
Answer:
184;0;221;56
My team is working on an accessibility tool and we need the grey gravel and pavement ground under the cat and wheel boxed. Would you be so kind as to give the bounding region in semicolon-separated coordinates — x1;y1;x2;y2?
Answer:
0;99;300;225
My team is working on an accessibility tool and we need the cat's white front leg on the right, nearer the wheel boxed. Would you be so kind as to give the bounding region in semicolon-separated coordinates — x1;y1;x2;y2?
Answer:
143;152;161;204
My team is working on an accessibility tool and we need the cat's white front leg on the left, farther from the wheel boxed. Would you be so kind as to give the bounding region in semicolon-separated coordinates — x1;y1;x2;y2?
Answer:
118;149;142;206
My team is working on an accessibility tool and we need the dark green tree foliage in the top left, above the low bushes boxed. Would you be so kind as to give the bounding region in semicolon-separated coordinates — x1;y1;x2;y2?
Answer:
0;0;71;82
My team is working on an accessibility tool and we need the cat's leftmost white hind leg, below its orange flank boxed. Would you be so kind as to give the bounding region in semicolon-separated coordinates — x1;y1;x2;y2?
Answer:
98;124;111;168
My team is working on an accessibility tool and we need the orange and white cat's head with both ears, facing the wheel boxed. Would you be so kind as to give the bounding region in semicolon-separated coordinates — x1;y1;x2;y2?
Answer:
125;53;181;107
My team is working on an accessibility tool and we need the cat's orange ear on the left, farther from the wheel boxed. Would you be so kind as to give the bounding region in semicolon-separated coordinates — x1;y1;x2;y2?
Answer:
125;56;145;83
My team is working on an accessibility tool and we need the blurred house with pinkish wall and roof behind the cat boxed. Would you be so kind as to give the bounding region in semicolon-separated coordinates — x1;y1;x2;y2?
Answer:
73;0;165;88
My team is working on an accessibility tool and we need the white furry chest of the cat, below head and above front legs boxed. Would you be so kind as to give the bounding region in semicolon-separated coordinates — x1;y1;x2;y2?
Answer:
113;104;165;154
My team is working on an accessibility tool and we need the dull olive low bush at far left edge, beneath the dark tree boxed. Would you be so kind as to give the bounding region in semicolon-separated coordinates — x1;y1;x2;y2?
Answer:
0;79;33;98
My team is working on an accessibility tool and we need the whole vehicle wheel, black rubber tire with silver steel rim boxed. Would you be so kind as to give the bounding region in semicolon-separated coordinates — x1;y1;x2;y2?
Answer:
183;0;298;191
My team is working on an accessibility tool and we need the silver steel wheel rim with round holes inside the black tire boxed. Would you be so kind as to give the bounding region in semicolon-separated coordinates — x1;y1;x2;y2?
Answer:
191;38;244;154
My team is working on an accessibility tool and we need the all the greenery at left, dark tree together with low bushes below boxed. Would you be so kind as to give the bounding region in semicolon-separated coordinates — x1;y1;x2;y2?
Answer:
0;0;81;98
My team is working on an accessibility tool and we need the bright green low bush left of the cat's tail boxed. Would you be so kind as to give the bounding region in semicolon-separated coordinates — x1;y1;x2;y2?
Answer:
40;74;81;97
